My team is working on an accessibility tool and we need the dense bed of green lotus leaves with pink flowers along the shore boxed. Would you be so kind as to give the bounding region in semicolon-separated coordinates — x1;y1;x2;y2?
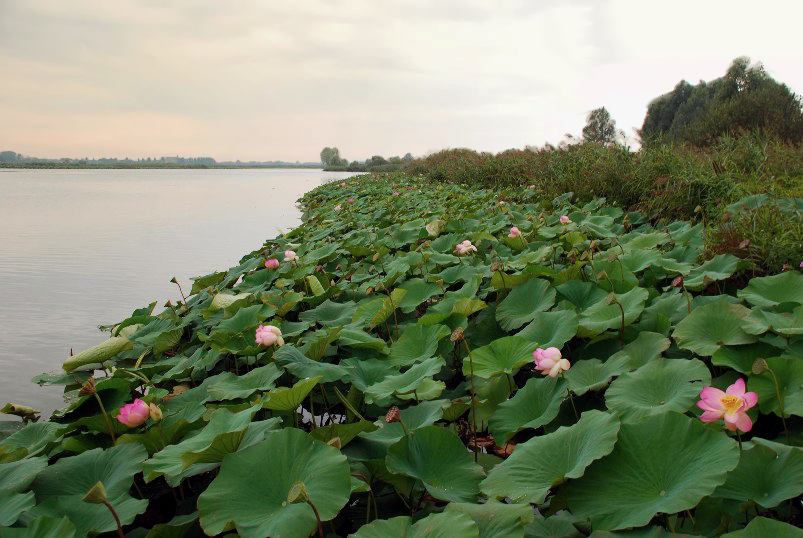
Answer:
0;176;803;538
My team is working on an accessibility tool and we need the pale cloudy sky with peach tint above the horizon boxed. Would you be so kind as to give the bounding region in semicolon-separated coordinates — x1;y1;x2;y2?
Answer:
0;0;803;161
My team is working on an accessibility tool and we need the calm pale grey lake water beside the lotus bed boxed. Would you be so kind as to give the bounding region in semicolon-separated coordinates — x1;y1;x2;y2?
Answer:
0;170;351;412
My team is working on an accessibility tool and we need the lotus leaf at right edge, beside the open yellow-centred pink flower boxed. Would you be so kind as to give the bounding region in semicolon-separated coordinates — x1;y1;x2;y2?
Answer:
747;357;803;416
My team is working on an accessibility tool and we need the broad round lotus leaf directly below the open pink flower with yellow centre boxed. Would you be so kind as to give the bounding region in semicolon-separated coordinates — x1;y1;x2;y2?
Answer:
566;413;739;530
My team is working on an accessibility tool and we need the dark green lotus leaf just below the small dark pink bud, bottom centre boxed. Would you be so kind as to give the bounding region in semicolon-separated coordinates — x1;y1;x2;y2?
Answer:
385;426;485;502
